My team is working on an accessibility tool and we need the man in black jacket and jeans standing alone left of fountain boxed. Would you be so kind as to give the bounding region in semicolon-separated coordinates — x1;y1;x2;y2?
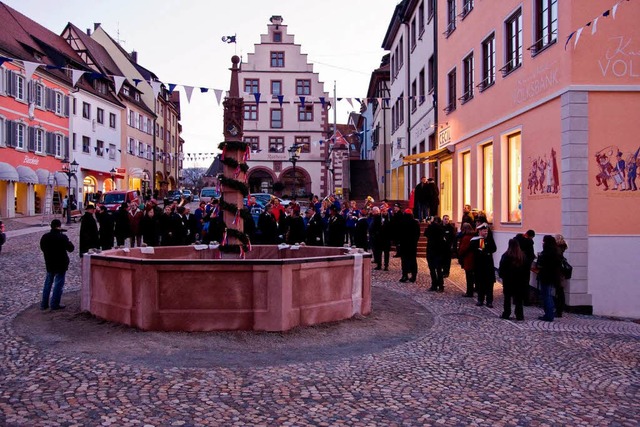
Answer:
40;219;74;310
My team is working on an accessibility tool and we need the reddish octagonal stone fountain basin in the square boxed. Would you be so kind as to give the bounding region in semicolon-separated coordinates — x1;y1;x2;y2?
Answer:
81;246;371;331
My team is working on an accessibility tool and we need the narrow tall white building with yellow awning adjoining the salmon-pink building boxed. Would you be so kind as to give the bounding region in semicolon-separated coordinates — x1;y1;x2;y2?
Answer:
382;0;437;199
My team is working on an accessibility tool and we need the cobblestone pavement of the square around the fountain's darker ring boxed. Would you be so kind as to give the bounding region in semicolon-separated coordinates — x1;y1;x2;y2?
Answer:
0;224;640;426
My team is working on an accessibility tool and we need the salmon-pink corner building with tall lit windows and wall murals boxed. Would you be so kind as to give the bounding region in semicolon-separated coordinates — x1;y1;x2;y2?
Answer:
435;0;640;317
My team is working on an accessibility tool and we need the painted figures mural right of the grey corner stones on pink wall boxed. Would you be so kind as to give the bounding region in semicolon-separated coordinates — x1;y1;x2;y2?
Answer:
596;145;640;191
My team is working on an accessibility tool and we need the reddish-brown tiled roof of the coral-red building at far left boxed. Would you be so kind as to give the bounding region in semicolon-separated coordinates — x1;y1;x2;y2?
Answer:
0;3;86;82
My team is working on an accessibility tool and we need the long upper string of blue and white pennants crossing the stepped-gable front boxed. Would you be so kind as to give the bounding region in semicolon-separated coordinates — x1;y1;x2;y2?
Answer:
0;56;396;108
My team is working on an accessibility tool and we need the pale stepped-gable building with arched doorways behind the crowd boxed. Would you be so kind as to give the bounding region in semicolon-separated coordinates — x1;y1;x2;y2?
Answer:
239;16;330;196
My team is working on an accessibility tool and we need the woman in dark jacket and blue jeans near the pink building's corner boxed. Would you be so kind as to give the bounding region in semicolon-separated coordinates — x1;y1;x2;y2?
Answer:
536;235;562;322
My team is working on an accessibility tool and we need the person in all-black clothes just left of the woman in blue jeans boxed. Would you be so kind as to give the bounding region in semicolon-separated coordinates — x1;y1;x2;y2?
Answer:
498;239;530;320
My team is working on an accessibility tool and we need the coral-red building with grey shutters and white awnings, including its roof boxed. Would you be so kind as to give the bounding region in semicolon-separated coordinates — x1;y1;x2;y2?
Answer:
0;3;75;218
